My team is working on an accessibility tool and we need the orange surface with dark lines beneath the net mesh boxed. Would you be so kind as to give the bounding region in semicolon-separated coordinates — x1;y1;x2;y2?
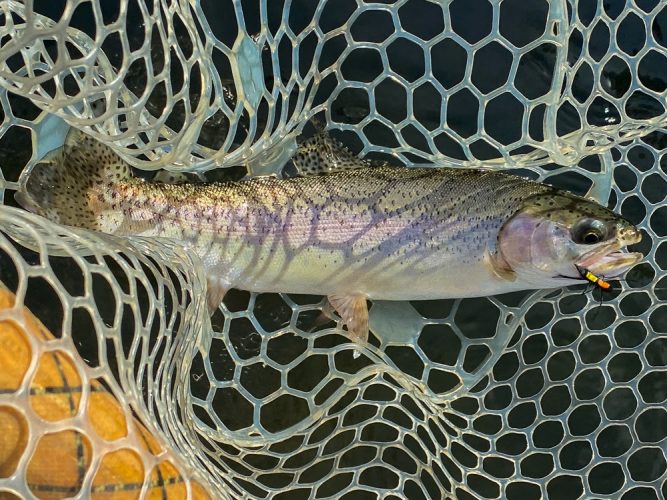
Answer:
0;287;210;500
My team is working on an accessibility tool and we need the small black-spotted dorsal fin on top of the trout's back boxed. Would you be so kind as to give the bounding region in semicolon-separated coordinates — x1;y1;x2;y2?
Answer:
292;129;372;176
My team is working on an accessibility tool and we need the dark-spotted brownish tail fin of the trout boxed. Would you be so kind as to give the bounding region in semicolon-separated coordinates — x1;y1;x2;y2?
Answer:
15;131;132;229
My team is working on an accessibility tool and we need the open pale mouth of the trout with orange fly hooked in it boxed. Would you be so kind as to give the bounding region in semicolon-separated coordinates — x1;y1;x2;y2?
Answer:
575;229;644;278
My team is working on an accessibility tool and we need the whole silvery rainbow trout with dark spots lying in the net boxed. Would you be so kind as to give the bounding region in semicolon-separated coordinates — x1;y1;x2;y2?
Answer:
17;133;642;340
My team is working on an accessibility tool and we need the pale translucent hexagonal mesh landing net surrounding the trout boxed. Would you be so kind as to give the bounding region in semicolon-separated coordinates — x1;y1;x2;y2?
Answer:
0;0;667;498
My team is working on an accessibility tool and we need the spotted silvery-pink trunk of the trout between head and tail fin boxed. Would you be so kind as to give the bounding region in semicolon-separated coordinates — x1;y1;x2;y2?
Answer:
102;167;549;300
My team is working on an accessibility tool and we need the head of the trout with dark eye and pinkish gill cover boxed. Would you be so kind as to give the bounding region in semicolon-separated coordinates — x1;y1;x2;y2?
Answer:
497;190;643;288
